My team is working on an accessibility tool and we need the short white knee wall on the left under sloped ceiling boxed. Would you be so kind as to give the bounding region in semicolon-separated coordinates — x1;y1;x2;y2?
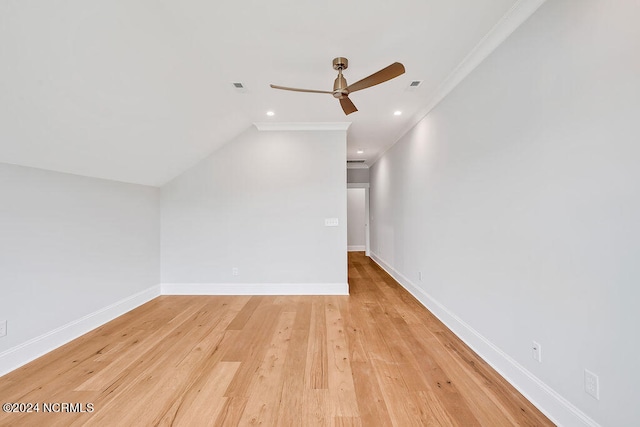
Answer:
0;163;160;375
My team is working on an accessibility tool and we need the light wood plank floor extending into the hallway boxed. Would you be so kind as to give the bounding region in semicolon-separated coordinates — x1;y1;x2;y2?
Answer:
0;253;553;427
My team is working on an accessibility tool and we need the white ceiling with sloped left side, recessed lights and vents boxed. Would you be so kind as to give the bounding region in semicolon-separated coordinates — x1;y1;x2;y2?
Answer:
0;0;543;186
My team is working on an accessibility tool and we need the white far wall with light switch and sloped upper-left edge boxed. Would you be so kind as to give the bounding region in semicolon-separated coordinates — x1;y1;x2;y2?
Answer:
161;127;348;294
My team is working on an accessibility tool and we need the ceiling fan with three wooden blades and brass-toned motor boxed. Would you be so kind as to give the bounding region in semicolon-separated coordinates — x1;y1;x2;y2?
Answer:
271;57;404;115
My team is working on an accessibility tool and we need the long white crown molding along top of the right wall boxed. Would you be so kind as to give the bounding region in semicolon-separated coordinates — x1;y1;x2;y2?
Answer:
370;0;546;165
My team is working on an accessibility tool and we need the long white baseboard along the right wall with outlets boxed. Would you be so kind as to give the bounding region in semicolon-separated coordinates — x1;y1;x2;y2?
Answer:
371;252;600;427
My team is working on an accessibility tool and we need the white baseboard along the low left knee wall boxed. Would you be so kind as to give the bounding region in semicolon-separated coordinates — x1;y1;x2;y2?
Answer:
0;285;160;376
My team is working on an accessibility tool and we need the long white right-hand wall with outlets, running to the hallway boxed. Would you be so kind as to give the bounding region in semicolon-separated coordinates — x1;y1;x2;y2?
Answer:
371;0;640;426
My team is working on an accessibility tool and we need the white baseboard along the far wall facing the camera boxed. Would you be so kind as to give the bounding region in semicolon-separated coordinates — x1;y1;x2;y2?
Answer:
161;283;349;295
